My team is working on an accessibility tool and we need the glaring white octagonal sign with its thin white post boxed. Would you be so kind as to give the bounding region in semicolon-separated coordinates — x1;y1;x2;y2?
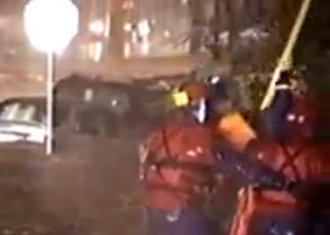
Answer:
24;0;79;154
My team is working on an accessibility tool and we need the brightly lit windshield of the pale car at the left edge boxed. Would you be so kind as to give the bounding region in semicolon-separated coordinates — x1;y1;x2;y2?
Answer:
0;102;45;123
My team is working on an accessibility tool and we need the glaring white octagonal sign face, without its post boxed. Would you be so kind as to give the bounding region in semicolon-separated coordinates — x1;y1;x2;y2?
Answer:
24;0;79;54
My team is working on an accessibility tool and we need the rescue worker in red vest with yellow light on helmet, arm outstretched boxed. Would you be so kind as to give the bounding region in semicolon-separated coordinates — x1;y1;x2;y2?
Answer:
141;78;300;235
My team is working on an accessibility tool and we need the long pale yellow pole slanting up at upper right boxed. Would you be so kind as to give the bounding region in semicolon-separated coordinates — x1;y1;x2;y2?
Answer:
260;0;312;110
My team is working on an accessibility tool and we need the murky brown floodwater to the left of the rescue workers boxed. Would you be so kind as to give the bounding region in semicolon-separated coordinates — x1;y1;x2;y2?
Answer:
0;140;144;235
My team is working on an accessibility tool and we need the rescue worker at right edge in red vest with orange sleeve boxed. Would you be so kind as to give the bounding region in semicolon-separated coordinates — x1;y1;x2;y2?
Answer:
217;70;330;235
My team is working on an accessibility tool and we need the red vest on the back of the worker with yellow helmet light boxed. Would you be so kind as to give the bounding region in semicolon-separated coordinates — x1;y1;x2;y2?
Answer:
143;118;214;210
